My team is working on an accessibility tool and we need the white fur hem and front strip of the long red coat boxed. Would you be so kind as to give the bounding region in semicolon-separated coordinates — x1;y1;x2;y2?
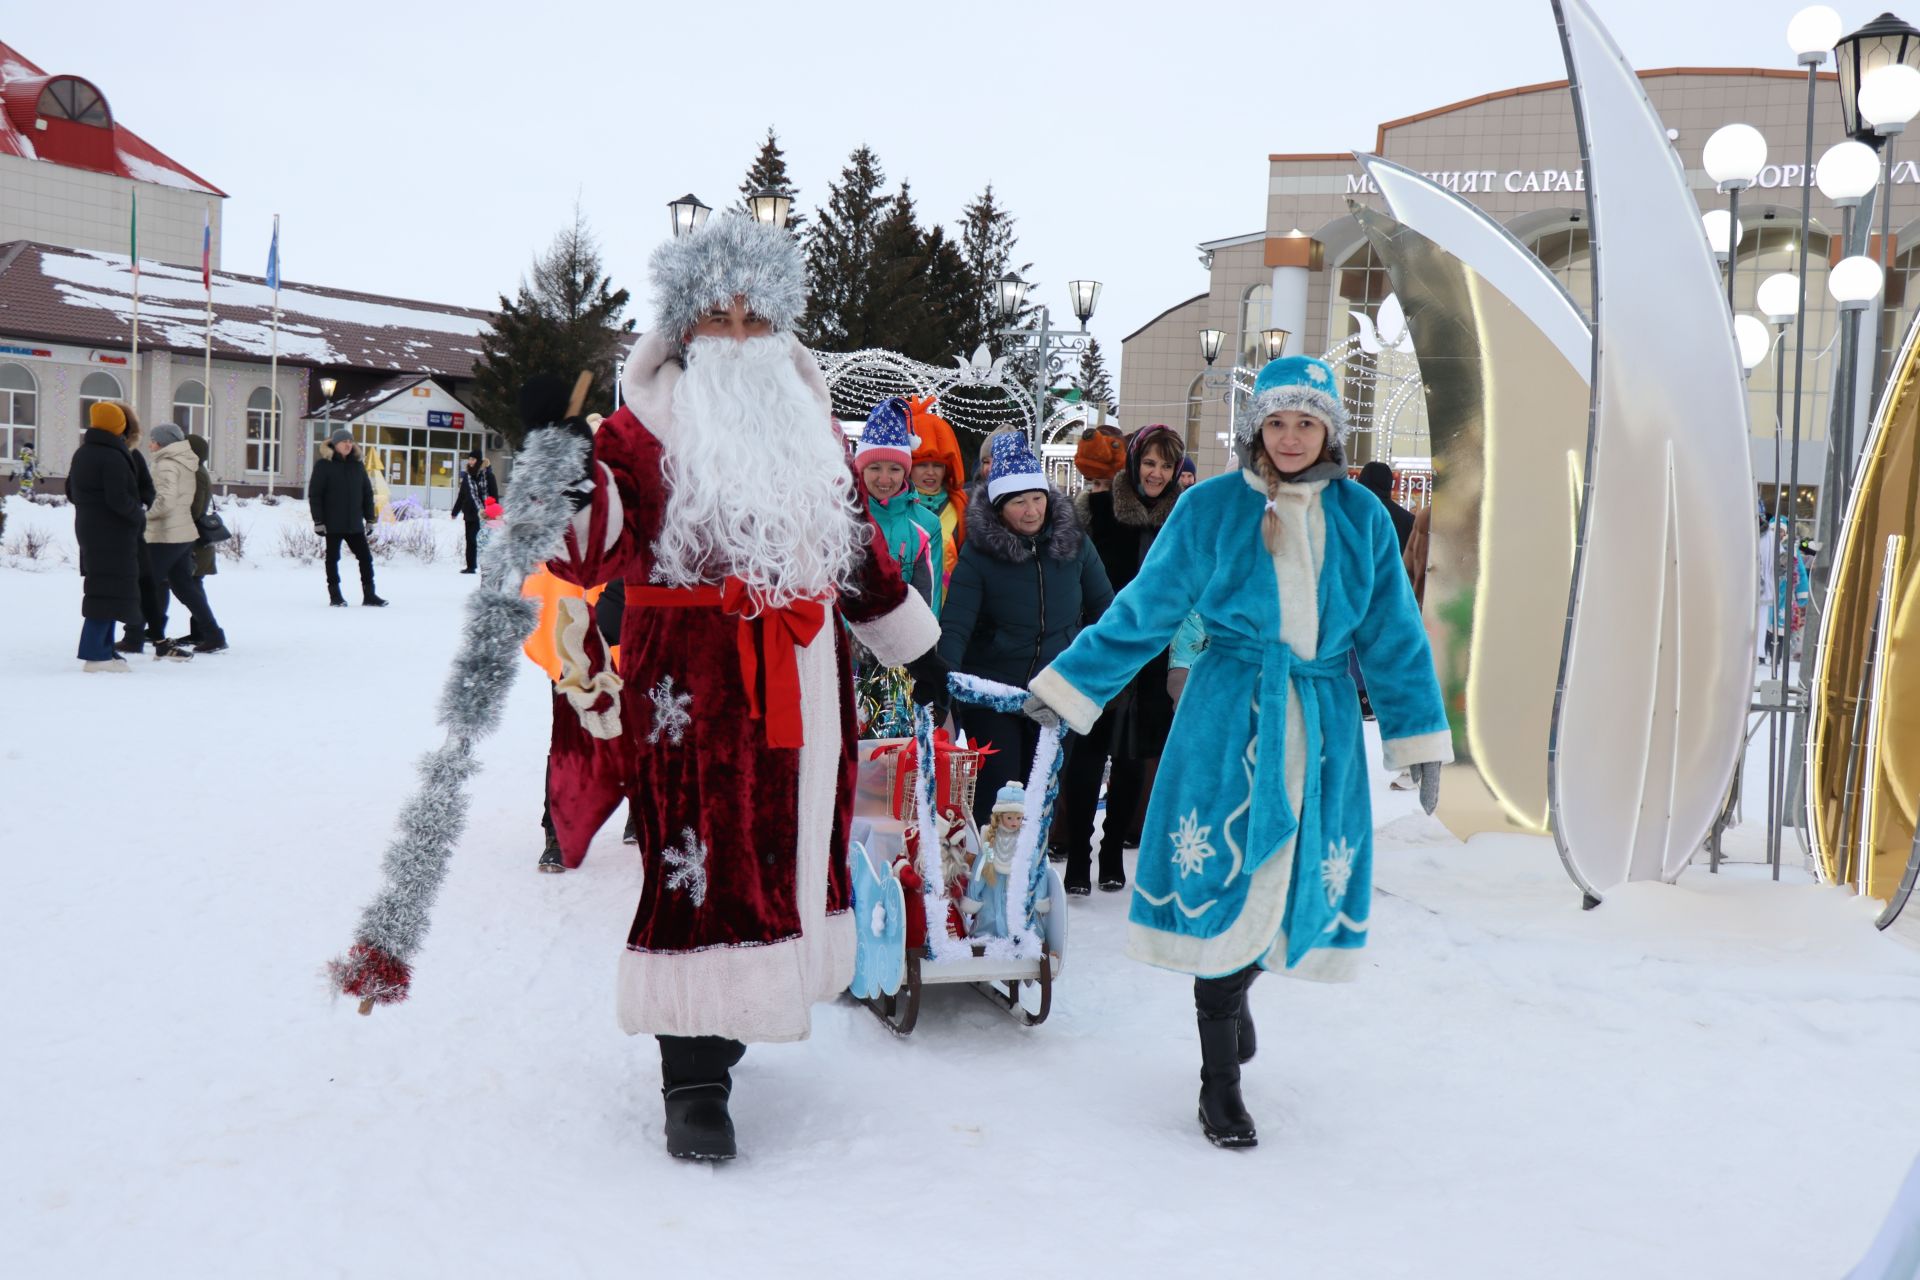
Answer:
616;610;856;1044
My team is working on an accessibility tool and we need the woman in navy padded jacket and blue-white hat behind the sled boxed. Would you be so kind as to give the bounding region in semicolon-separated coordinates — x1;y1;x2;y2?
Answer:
935;441;1114;840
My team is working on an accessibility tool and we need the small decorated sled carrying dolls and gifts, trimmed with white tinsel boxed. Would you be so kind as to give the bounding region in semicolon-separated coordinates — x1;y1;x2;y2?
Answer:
849;676;1068;1036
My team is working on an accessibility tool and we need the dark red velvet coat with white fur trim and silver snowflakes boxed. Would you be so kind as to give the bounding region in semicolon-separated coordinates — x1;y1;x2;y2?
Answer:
549;376;937;1040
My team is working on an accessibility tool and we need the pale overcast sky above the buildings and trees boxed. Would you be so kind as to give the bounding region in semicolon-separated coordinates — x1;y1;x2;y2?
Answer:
0;0;1850;358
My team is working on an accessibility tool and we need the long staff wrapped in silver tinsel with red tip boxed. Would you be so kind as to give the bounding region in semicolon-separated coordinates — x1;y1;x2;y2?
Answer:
326;374;589;1013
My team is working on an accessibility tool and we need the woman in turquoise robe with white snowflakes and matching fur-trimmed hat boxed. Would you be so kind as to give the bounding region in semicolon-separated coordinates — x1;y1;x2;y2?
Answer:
1029;355;1453;1146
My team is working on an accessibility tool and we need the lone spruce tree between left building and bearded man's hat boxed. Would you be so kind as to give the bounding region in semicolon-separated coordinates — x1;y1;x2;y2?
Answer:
467;205;634;447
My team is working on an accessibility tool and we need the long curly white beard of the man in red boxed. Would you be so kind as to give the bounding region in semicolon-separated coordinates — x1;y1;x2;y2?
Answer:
653;336;860;608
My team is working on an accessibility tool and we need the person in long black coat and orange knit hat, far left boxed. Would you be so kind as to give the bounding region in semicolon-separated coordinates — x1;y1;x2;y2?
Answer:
67;401;146;672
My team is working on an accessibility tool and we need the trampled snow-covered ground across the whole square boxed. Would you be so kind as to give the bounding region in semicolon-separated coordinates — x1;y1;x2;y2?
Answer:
0;501;1920;1280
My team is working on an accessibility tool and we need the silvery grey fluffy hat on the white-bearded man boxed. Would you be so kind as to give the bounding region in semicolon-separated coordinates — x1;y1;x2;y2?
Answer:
647;213;806;353
